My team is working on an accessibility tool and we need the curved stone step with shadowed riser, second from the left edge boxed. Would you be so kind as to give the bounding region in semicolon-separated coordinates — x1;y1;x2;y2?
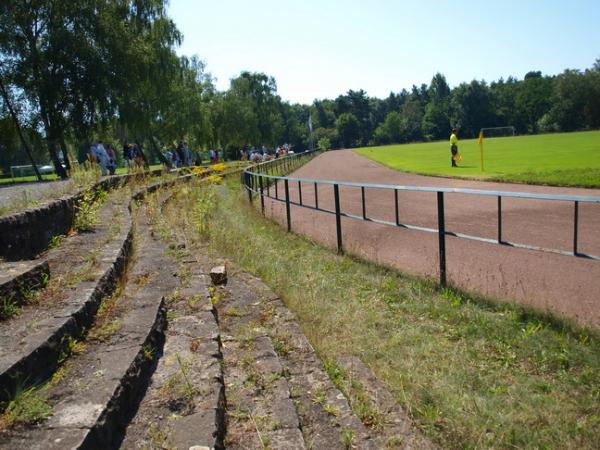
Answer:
0;193;133;401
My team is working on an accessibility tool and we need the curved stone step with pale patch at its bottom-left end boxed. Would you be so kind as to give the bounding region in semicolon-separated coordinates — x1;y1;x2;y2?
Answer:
0;195;179;449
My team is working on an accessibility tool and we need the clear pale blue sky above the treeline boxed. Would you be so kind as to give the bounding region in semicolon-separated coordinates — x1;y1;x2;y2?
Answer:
169;0;600;103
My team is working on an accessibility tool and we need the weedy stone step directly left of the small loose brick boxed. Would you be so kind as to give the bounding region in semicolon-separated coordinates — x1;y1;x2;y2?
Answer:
121;256;225;449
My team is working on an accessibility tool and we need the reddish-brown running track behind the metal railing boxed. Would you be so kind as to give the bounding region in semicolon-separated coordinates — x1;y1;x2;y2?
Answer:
267;151;600;327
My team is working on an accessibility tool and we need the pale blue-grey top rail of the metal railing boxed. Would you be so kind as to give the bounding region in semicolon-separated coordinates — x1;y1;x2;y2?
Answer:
246;170;600;203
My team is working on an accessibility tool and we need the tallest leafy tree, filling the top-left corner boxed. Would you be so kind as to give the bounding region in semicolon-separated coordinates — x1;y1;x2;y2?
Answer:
0;0;185;177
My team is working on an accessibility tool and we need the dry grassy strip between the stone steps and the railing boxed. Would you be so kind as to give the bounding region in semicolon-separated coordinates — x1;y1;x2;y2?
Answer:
169;180;600;449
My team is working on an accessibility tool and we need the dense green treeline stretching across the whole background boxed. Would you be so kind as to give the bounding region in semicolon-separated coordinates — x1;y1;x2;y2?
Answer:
0;0;600;176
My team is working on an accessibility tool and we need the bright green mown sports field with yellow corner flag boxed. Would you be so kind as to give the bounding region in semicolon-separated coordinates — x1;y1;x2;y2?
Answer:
355;131;600;188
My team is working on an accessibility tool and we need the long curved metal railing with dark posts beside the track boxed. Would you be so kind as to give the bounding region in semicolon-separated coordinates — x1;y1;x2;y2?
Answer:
242;151;600;286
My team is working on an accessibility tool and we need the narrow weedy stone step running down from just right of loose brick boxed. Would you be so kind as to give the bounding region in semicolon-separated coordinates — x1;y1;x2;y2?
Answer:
214;274;306;449
